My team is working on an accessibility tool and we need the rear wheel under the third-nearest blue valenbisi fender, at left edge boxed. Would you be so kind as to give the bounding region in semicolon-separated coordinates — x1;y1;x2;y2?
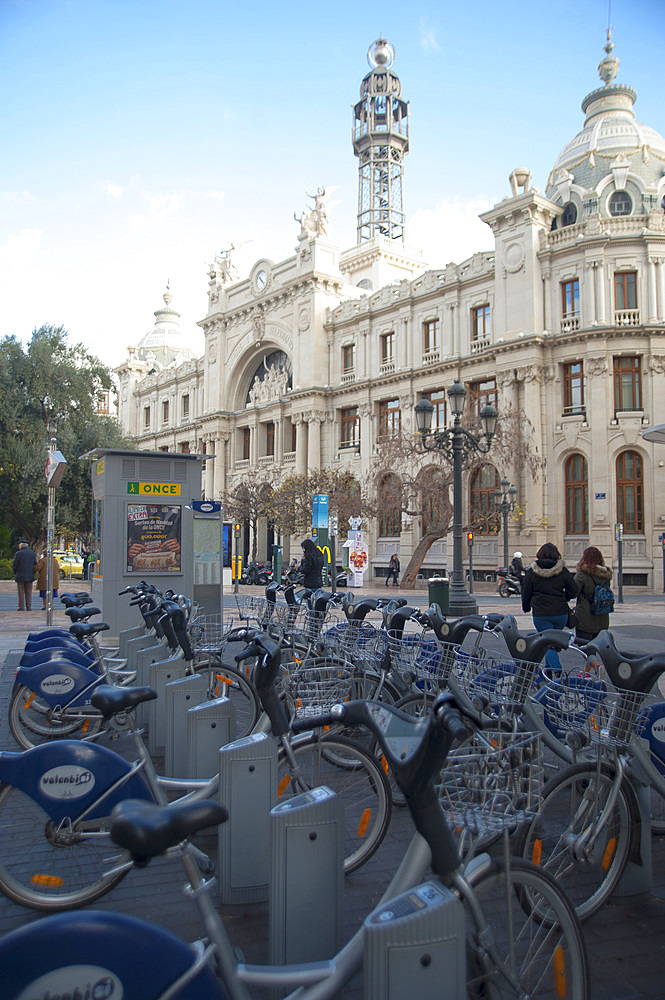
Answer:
9;684;103;750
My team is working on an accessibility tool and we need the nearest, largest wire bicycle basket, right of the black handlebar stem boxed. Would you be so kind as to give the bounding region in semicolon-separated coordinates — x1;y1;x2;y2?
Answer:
441;731;543;835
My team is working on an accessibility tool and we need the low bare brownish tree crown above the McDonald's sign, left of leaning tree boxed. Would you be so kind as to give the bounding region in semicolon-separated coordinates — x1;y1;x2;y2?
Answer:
270;469;376;538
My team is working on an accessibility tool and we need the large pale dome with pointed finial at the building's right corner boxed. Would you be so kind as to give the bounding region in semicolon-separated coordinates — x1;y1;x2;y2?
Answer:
546;31;665;203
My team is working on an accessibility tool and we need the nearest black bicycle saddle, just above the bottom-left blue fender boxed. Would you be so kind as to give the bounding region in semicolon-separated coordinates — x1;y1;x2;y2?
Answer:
109;799;229;865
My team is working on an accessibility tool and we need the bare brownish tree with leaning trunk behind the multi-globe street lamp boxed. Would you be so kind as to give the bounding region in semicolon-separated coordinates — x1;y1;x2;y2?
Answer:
369;407;543;589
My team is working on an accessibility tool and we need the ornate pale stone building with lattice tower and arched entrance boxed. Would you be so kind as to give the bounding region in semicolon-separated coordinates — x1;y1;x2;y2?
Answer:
117;38;665;588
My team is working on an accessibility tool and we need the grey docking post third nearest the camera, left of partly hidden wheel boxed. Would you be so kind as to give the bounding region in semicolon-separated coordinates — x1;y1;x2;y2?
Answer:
217;733;277;903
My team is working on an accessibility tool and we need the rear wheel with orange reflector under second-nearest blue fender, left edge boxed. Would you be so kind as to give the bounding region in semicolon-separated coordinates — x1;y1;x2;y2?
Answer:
0;785;131;912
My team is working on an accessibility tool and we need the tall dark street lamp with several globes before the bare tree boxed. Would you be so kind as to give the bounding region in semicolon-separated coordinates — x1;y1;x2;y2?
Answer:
415;379;498;617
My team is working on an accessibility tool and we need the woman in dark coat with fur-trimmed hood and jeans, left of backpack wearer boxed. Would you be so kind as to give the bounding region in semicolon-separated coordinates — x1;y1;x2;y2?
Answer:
522;542;577;672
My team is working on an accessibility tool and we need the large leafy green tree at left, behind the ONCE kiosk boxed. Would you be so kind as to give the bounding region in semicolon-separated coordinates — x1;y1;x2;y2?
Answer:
0;326;128;545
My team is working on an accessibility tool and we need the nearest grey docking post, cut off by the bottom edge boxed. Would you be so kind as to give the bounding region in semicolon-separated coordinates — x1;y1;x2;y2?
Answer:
363;882;467;1000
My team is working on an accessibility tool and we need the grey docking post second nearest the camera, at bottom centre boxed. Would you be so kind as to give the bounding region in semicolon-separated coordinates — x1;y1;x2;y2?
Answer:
270;785;342;968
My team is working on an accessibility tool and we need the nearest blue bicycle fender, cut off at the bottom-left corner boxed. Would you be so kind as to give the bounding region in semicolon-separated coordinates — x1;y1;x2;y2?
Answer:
0;910;226;1000
